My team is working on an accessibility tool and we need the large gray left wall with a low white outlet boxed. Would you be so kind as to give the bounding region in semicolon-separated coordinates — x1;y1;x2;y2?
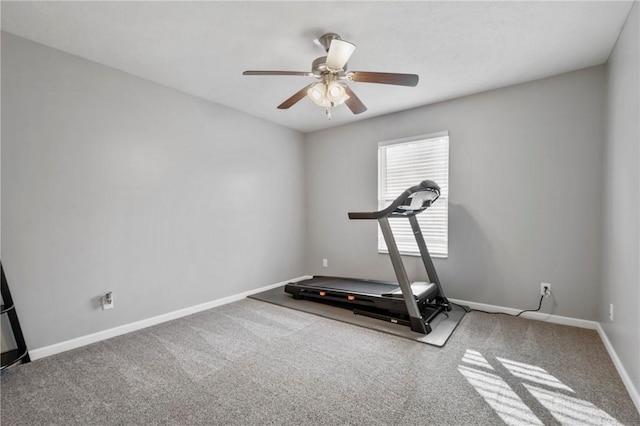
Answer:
2;33;305;349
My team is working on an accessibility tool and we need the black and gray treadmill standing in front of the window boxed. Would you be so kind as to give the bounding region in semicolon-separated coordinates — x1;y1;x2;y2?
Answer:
285;180;451;334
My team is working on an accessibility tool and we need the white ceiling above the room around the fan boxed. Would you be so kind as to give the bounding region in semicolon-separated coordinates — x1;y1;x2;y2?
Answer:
2;1;632;132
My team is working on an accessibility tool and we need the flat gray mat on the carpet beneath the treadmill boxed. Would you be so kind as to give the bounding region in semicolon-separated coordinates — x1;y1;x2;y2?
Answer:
249;286;465;346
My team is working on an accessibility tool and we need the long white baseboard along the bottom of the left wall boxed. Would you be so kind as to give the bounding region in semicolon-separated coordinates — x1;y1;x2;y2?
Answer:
29;275;311;361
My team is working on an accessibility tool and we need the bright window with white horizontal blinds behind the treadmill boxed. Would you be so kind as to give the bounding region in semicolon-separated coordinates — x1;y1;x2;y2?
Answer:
378;132;449;258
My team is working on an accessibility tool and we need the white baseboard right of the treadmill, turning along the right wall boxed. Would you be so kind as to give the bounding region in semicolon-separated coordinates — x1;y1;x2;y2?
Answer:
449;298;640;413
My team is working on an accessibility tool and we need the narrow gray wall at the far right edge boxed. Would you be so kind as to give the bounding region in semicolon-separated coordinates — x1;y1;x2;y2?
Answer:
599;2;640;391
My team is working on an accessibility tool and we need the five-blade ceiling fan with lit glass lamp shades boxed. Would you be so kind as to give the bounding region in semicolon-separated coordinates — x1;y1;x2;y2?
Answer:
242;33;418;119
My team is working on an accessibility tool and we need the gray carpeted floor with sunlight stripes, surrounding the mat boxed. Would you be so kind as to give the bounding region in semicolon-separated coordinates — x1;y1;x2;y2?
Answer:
1;299;640;426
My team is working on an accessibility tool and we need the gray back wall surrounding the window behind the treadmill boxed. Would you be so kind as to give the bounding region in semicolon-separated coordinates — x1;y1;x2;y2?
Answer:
306;66;605;320
